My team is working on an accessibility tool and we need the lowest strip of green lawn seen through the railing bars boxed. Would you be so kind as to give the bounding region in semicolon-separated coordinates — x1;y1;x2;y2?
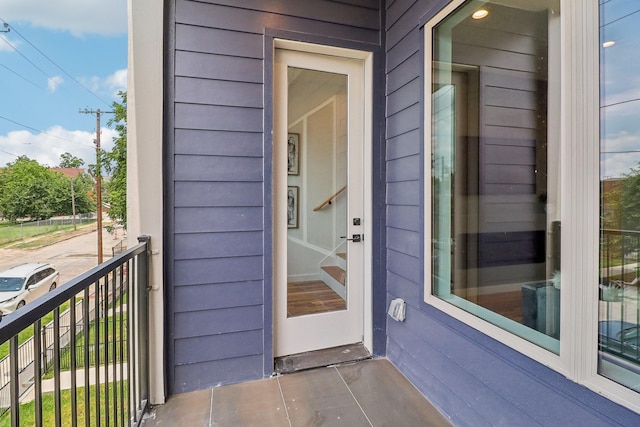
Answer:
0;381;129;427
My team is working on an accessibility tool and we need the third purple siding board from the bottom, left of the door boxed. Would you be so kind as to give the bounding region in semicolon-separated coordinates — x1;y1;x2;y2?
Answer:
175;305;264;339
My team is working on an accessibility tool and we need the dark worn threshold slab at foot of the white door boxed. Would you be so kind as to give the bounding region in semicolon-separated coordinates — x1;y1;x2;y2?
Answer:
274;343;371;374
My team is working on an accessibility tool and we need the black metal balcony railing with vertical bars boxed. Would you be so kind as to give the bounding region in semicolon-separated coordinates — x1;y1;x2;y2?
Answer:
0;236;149;427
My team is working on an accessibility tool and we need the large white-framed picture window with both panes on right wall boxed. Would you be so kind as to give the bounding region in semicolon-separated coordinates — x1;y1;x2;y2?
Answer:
424;0;640;411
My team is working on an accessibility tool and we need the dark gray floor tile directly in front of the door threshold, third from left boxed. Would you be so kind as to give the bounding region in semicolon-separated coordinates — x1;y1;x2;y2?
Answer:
278;368;370;427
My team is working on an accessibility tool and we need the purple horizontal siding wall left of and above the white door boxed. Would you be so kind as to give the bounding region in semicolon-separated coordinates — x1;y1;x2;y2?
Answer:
165;0;384;393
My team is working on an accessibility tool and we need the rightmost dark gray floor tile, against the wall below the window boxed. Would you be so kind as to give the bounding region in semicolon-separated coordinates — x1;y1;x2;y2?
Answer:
337;359;451;427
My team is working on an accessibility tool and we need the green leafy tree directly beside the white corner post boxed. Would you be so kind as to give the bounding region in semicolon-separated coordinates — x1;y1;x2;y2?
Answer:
104;91;127;228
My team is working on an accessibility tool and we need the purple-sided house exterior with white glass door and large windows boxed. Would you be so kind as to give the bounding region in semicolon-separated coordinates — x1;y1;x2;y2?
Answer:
128;0;640;426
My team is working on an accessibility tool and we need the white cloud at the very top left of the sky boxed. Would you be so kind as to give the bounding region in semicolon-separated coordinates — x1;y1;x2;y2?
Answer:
1;0;127;37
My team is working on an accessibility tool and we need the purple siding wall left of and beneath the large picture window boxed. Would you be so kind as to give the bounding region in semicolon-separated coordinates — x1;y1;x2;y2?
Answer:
386;0;640;427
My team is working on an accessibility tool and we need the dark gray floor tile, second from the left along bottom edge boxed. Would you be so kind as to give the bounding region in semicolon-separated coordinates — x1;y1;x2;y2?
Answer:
211;378;289;427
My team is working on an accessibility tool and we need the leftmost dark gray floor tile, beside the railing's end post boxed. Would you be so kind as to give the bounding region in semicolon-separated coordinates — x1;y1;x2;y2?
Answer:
142;389;211;427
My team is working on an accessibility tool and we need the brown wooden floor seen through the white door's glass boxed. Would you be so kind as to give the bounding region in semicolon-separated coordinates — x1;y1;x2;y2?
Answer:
287;280;347;317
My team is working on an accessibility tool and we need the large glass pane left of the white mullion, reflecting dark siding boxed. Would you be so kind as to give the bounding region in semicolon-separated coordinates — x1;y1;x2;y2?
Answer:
431;0;561;352
